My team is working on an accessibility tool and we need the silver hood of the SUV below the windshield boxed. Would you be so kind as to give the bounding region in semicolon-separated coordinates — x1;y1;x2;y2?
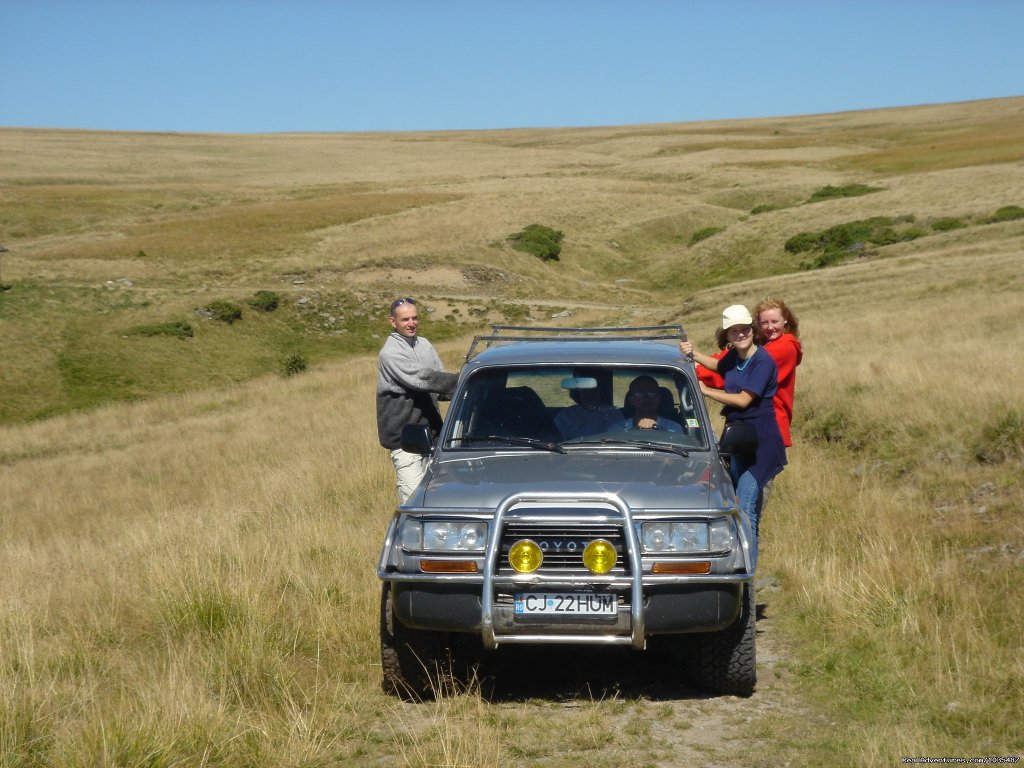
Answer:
407;450;734;511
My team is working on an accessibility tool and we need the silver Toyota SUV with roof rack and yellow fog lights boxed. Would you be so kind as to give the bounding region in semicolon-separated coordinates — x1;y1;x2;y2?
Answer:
377;326;756;699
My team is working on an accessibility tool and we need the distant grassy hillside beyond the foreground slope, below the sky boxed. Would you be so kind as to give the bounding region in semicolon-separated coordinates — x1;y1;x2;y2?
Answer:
0;99;1024;422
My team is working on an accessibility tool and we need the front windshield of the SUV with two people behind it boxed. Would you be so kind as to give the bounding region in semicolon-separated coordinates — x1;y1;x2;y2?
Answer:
444;366;709;453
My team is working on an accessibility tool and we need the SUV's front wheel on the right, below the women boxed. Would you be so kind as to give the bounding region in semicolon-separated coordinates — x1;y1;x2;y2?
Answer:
693;584;758;697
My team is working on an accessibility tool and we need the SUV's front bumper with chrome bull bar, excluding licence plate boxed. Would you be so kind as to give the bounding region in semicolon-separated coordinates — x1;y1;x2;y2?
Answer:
378;493;753;649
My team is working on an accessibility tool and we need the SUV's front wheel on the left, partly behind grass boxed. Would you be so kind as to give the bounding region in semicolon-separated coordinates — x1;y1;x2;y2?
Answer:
381;584;452;701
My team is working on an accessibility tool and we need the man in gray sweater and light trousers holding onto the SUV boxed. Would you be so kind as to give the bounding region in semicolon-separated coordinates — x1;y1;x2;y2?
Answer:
377;297;459;504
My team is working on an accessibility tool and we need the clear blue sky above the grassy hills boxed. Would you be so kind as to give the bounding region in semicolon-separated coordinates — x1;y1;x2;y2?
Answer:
0;0;1024;133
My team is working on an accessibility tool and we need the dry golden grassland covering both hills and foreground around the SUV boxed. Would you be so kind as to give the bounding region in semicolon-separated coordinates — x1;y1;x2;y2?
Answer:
0;98;1024;768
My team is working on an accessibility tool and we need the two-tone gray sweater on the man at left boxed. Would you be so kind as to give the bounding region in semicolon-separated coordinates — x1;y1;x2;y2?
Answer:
377;332;459;451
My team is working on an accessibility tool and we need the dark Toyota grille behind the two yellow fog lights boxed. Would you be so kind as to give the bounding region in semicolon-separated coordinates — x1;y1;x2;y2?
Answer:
498;522;630;575
